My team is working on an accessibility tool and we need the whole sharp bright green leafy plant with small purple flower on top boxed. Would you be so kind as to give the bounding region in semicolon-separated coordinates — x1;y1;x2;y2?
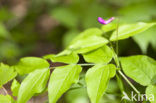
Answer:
0;18;156;103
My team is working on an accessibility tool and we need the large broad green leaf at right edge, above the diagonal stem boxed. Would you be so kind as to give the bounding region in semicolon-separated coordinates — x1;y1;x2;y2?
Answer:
120;55;156;86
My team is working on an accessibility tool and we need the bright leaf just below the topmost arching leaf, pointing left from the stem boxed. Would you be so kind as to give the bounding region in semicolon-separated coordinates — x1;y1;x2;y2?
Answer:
69;35;108;53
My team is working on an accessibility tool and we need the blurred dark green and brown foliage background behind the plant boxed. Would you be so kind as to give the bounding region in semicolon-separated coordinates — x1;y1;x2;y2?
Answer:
0;0;156;103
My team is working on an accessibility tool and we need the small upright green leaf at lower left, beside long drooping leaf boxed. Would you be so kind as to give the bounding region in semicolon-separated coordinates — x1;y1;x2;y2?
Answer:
11;79;20;96
